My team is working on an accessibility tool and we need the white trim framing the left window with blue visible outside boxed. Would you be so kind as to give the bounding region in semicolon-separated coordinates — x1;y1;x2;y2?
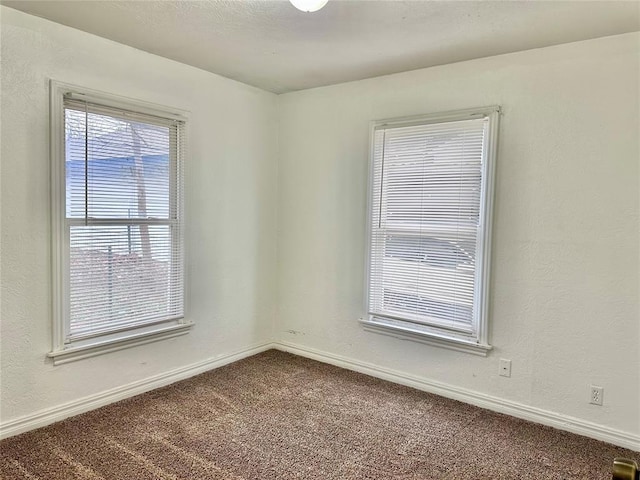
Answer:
47;80;193;365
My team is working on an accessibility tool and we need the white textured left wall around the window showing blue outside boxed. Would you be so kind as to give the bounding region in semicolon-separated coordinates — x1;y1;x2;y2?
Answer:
0;7;277;422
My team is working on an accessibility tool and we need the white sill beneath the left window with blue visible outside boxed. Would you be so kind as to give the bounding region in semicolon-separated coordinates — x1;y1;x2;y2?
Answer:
47;323;193;365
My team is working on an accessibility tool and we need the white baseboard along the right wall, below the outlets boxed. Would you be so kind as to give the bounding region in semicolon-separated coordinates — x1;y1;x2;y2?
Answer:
274;342;640;451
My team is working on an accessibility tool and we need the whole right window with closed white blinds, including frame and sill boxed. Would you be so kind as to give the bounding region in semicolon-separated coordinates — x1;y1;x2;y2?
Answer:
363;107;499;355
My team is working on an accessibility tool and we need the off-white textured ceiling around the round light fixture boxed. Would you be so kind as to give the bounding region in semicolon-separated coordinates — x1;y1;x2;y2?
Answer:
0;0;640;93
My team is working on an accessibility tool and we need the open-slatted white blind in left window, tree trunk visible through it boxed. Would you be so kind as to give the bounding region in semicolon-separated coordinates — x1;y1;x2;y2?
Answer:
64;99;184;341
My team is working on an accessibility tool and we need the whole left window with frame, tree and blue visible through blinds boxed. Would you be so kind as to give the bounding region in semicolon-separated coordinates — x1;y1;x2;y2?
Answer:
49;82;189;364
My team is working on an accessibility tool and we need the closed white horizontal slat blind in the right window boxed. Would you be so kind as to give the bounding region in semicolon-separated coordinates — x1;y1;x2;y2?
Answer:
369;118;487;333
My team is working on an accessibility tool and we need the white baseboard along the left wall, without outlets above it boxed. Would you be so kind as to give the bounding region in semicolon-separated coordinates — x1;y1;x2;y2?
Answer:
0;342;275;439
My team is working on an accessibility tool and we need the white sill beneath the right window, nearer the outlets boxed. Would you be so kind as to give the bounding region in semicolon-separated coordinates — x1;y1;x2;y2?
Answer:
360;319;493;357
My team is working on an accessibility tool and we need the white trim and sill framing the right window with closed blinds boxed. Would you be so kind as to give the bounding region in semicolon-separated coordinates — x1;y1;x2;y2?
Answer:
360;106;501;356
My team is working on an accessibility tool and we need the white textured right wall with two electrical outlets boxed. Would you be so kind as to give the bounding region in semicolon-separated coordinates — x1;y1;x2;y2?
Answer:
277;34;640;438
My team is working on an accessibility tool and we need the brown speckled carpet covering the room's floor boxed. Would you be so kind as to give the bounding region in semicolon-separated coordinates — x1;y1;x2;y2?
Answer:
0;350;640;480
